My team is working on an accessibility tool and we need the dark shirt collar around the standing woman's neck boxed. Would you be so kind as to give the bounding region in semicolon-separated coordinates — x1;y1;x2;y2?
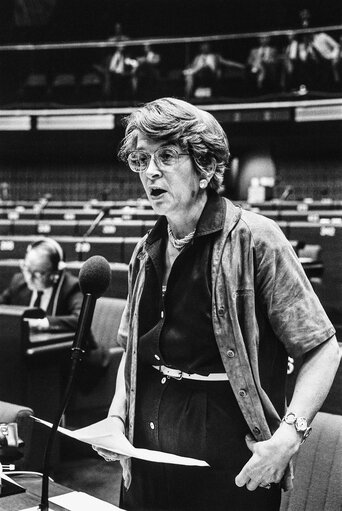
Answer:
146;191;226;245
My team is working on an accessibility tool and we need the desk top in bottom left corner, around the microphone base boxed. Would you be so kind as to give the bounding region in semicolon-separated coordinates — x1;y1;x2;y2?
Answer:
0;476;72;511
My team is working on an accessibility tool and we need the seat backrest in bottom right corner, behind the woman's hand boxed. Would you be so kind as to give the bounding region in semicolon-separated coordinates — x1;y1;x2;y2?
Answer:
280;412;342;511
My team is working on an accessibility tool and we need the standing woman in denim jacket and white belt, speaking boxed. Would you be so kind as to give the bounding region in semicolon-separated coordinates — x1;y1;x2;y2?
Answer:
93;98;339;511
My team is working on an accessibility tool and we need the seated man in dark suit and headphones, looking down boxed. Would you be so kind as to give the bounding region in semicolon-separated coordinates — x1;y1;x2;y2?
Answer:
0;238;110;390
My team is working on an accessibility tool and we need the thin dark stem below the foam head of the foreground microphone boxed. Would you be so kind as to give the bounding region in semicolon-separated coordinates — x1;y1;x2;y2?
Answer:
37;293;97;511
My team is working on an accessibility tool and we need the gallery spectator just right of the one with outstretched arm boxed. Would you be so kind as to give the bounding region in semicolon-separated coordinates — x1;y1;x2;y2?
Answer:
247;35;279;92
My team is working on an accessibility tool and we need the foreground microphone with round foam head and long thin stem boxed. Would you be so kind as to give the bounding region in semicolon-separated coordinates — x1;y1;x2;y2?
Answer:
38;255;111;511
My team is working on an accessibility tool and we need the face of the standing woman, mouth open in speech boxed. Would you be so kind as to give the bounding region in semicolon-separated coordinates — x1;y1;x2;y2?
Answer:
136;132;200;223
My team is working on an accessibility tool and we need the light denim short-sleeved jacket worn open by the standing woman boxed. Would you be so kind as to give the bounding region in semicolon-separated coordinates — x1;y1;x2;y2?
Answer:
118;199;335;489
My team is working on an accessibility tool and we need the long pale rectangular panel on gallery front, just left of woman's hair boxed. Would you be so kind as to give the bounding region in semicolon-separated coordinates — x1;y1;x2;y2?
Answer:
36;114;115;130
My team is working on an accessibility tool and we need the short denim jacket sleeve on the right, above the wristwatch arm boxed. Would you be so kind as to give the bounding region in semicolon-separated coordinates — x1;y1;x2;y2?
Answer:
253;220;335;356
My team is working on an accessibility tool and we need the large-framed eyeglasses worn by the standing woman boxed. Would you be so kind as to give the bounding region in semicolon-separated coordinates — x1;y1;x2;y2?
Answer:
127;147;189;172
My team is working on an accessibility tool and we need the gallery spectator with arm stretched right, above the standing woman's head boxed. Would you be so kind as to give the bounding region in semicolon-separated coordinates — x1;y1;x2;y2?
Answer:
183;42;245;98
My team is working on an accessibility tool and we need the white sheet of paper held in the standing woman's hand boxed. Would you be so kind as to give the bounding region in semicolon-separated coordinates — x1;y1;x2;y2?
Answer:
33;417;209;467
